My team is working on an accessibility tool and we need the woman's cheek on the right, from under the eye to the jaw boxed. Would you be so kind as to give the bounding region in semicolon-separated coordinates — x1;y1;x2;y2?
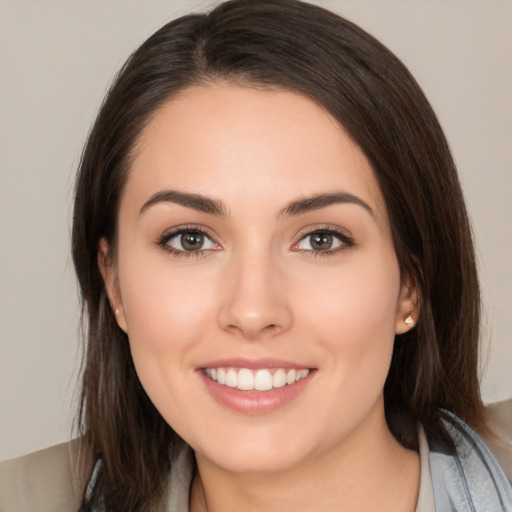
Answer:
303;255;400;436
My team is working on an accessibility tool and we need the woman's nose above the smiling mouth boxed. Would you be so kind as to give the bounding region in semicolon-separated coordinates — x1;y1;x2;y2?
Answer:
218;252;292;340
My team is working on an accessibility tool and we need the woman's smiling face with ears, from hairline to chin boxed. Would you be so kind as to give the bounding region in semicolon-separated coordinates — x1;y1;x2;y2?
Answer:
99;84;415;472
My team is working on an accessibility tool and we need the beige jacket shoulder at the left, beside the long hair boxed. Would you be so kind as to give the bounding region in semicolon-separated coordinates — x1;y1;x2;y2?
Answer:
0;440;87;512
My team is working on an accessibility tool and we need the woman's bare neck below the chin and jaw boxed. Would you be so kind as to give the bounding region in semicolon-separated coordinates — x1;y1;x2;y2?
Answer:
190;411;420;512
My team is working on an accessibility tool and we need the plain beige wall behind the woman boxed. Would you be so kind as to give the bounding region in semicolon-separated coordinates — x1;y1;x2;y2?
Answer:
0;0;512;459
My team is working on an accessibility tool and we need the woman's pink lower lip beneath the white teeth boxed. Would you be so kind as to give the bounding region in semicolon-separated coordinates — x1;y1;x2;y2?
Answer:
198;370;314;416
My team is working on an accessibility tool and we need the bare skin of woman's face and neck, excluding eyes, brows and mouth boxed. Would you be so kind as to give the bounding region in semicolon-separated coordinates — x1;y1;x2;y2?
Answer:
98;83;419;512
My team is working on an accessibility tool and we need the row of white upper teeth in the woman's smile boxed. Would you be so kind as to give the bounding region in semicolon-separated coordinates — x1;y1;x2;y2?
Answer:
204;368;309;391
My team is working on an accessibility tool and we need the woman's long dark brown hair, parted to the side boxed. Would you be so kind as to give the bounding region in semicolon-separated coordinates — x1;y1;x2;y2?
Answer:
72;0;485;512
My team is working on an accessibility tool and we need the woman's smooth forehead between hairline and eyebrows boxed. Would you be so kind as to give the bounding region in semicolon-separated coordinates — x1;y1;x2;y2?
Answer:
126;84;385;224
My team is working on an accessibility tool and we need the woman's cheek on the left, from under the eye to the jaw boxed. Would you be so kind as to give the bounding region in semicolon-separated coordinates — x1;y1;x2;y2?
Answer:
115;252;221;431
